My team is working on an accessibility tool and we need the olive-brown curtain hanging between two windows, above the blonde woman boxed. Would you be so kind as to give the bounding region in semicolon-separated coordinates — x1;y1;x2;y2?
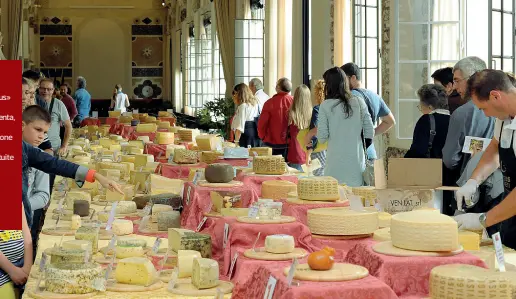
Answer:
214;0;237;97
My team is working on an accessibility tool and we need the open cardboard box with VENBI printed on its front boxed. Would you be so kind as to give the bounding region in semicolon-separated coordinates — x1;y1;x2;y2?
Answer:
375;158;446;214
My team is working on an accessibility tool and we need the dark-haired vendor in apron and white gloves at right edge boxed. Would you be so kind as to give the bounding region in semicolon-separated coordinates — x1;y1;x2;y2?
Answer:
455;70;516;249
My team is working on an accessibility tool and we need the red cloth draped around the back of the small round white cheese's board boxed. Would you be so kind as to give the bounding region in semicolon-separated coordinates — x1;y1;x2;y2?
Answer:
223;221;313;274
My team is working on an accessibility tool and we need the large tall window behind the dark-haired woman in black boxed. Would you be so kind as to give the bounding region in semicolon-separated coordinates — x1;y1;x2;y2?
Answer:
393;0;464;142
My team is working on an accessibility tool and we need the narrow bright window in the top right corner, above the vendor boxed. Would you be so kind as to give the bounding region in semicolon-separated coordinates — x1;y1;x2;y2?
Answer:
488;0;515;73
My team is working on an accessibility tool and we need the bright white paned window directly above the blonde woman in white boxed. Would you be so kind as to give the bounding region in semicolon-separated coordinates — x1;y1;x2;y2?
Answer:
235;20;264;85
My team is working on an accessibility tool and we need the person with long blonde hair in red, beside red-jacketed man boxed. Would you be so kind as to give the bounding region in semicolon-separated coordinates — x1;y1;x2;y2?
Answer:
287;84;312;171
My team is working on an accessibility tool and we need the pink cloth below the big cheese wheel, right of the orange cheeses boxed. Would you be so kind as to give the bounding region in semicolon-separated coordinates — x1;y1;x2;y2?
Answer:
346;244;487;296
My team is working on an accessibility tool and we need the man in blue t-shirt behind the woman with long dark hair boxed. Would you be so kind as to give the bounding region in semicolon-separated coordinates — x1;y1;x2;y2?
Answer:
341;62;396;160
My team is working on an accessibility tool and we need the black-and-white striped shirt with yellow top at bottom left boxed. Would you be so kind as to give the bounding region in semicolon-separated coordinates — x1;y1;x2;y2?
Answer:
0;230;25;286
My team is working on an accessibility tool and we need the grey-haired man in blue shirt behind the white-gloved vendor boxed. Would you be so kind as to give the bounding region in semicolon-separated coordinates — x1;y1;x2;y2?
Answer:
443;56;495;215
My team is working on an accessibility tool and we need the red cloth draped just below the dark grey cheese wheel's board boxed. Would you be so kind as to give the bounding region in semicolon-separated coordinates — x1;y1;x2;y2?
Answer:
180;182;258;229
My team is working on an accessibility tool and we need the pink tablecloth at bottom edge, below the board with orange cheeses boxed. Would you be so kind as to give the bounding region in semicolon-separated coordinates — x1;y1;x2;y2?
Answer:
231;263;398;299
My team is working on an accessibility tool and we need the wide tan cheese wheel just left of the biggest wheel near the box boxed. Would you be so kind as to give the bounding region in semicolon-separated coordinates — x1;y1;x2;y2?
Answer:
307;208;378;235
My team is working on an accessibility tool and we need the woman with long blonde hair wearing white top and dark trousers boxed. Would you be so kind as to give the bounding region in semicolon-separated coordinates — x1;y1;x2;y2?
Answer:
231;83;261;148
